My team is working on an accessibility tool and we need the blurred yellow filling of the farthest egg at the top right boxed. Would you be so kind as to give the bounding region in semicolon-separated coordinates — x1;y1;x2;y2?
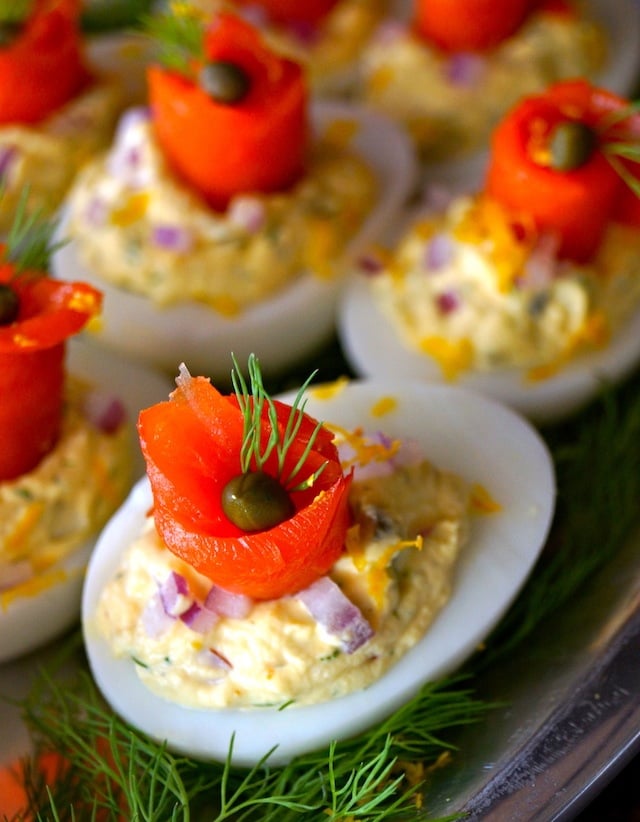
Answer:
360;3;610;160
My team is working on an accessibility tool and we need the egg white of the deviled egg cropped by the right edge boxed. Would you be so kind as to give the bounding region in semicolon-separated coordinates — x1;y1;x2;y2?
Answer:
338;275;640;423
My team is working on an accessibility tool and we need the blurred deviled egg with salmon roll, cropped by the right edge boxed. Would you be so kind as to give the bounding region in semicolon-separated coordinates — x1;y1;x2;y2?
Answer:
339;80;640;421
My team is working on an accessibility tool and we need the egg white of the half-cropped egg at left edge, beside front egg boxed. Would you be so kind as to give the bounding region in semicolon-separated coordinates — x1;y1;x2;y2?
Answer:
0;339;171;662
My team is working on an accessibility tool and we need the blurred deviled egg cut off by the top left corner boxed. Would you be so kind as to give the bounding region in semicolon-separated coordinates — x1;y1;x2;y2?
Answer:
0;0;124;232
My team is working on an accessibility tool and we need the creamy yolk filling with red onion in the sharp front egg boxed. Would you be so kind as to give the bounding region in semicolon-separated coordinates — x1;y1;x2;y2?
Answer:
96;424;484;708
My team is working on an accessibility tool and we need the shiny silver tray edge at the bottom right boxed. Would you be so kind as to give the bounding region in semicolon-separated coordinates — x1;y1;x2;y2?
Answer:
426;532;640;822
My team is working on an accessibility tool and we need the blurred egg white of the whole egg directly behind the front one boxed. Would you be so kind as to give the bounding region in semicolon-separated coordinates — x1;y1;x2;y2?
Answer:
53;103;415;381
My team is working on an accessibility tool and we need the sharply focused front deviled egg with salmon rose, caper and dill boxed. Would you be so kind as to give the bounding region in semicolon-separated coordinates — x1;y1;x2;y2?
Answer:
83;369;554;765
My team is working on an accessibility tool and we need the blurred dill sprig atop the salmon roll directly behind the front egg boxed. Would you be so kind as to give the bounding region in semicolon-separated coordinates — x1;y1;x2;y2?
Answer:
143;2;207;78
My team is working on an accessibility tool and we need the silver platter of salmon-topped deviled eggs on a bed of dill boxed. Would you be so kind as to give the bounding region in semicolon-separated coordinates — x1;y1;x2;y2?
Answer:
0;0;640;822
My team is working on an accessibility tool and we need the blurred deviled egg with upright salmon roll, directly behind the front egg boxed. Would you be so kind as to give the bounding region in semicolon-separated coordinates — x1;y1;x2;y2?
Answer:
53;8;414;378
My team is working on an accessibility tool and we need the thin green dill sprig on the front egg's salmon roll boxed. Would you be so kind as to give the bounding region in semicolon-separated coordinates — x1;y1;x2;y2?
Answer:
231;354;327;491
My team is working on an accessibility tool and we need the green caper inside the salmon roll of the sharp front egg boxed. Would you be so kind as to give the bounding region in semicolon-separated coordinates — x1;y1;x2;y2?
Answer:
222;471;295;531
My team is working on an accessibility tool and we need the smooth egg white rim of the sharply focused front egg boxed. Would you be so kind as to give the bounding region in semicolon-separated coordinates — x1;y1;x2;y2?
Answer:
82;380;555;766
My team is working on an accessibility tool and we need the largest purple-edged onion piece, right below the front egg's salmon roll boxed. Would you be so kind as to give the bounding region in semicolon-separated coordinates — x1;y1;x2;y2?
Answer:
296;576;373;654
